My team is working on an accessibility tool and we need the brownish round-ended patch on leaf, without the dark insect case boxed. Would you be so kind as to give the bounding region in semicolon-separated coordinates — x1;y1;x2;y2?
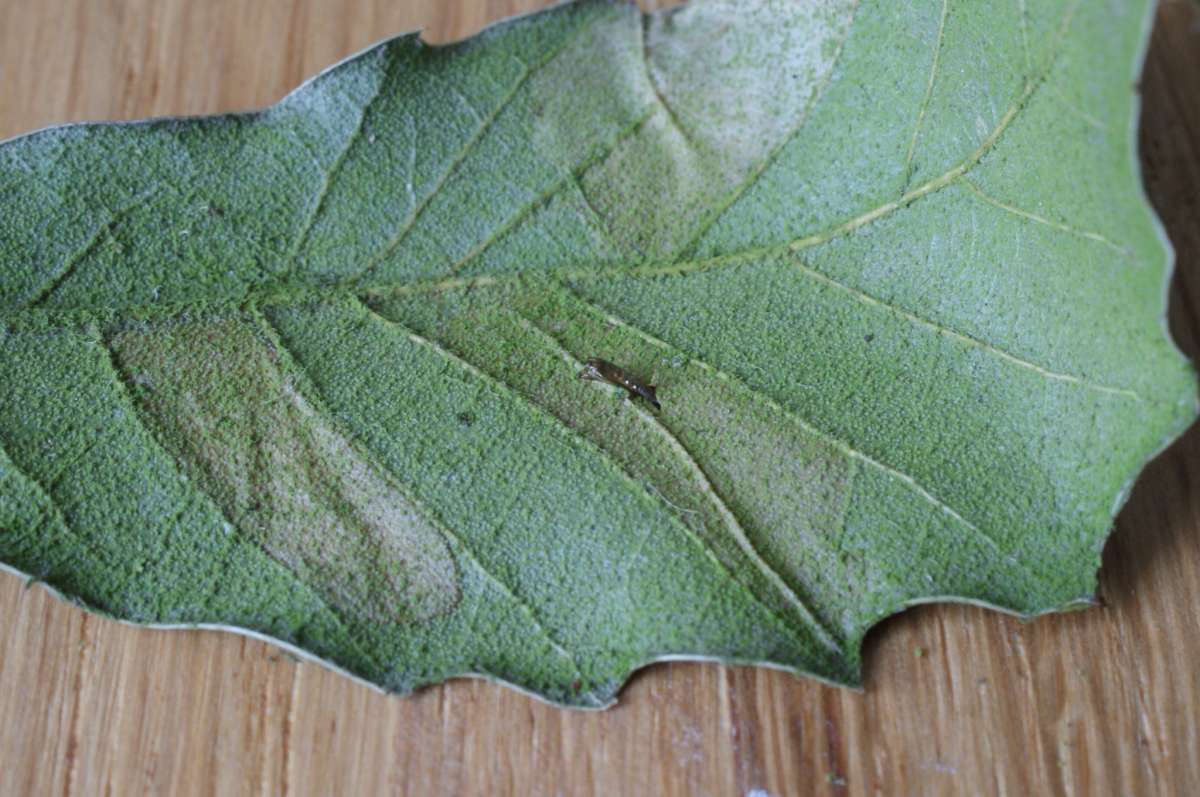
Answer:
110;317;458;623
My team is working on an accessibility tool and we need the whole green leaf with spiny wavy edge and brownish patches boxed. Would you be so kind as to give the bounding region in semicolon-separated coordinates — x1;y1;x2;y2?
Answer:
0;0;1196;706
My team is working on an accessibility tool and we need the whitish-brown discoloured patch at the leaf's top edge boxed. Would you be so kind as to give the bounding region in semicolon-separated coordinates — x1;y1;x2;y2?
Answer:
580;0;856;259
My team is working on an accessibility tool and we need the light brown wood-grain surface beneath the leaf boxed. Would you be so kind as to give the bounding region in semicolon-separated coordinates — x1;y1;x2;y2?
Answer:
0;0;1200;796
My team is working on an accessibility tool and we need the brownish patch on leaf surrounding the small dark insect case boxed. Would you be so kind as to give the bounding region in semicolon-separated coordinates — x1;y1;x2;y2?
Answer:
377;286;870;636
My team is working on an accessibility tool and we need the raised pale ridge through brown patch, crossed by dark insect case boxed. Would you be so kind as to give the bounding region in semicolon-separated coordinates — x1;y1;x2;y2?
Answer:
518;304;842;653
